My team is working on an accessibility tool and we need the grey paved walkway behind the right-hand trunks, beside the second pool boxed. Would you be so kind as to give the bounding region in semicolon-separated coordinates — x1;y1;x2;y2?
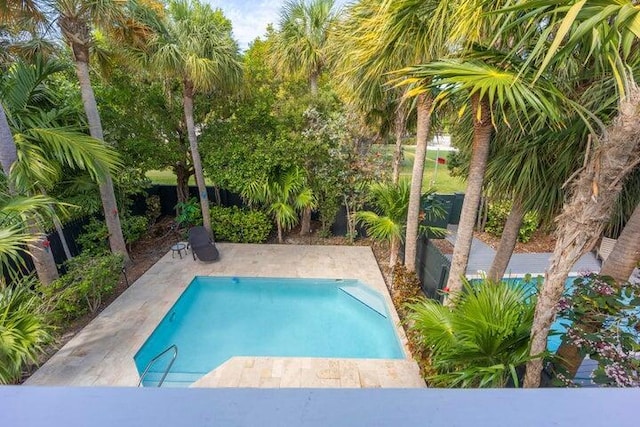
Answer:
445;225;600;279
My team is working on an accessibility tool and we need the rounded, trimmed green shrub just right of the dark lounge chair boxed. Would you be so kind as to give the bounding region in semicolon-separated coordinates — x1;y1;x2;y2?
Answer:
211;206;273;243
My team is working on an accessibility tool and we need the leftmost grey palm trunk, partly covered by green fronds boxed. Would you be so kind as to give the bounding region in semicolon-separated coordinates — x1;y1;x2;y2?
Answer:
0;104;58;285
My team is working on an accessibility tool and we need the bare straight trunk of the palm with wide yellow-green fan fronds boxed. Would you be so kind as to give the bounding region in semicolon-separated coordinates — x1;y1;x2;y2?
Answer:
445;94;493;303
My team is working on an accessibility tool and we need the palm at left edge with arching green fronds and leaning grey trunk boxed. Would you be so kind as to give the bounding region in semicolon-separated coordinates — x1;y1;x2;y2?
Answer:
0;58;118;284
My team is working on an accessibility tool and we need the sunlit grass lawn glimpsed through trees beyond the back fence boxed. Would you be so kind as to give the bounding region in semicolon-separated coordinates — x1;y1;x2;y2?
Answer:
147;145;466;194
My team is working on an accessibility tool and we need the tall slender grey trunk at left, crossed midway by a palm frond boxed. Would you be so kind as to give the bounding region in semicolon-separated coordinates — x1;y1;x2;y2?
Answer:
73;56;131;264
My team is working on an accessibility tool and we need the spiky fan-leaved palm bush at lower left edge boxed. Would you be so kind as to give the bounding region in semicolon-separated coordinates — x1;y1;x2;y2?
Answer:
0;281;51;384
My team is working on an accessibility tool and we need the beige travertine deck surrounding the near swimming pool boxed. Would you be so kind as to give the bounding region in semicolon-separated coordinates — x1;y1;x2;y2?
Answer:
25;243;425;388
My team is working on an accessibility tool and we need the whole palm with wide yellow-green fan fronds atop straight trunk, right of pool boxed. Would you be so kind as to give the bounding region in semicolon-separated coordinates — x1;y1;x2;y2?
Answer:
406;56;559;300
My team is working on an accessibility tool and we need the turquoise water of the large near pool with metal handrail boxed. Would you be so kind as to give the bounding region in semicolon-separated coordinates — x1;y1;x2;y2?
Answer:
135;277;404;387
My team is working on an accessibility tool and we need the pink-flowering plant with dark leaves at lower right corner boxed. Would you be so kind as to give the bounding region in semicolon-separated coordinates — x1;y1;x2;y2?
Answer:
558;273;640;387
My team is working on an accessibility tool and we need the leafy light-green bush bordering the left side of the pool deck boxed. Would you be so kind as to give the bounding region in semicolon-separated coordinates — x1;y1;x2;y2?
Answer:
40;252;124;323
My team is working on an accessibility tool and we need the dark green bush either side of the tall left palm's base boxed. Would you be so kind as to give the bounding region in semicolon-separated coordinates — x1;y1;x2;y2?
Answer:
77;215;149;254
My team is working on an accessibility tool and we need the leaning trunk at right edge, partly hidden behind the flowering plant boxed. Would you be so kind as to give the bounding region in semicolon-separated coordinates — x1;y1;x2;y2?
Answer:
557;204;640;378
